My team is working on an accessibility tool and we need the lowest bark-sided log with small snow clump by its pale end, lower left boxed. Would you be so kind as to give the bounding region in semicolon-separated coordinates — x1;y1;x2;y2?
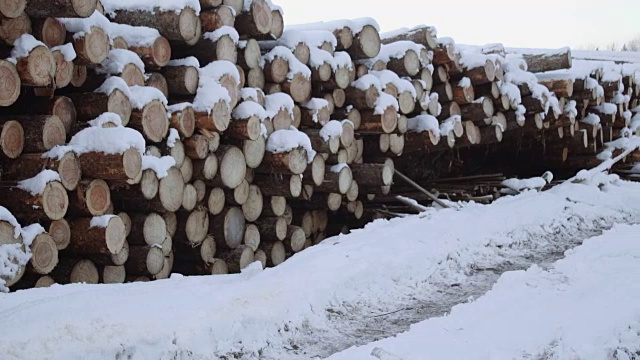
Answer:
67;216;131;256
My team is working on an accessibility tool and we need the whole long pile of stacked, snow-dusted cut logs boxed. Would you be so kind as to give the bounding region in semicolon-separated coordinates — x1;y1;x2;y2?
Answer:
0;0;640;289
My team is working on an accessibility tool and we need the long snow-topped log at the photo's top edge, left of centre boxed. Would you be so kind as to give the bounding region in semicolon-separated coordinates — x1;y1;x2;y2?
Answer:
111;7;202;43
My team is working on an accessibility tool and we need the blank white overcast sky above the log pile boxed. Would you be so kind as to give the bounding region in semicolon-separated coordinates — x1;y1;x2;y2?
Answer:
273;0;640;48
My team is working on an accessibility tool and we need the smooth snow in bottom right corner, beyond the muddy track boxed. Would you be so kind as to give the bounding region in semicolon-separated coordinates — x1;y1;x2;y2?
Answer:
329;225;640;360
